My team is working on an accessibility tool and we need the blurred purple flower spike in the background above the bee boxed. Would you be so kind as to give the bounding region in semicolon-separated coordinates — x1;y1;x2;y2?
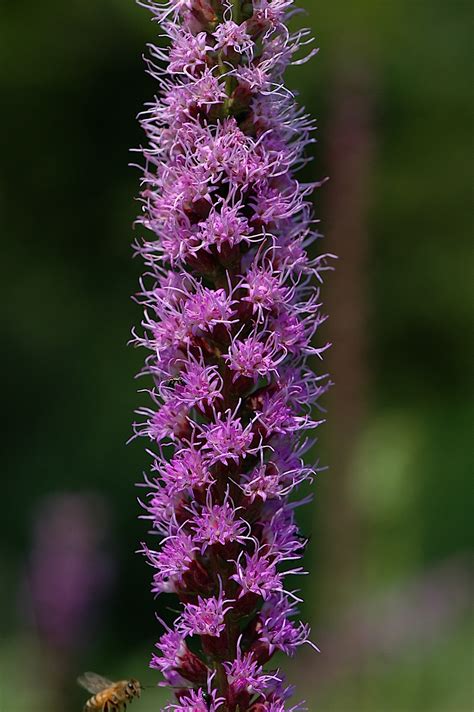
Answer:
27;494;112;655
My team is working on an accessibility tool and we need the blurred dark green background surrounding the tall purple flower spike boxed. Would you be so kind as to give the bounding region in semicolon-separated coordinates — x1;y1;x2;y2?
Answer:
0;0;474;712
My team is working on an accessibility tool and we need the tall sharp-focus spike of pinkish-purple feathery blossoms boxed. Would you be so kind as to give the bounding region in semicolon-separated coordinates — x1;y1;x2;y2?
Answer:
134;0;329;712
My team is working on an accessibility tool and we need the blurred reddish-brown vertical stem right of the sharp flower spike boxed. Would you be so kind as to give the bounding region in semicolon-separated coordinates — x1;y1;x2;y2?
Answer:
320;65;374;613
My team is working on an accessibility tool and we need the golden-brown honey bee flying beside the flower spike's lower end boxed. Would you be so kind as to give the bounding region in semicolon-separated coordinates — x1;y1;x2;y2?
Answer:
77;672;142;712
